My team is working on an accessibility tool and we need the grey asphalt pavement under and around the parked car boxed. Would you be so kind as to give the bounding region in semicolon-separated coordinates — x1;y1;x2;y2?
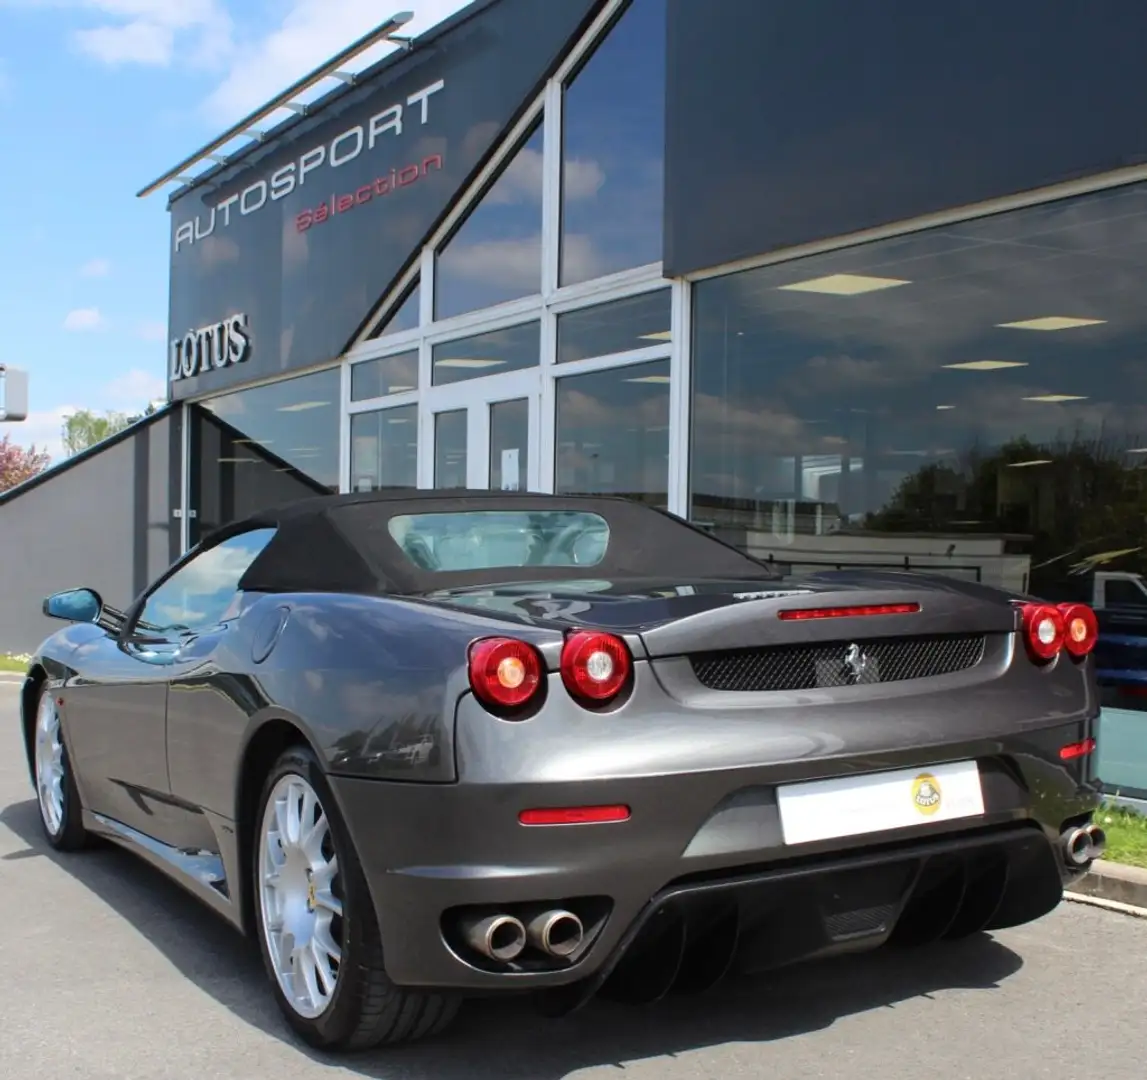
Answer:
0;686;1147;1080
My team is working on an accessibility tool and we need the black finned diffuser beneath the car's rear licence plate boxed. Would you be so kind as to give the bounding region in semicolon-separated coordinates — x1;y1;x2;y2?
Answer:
543;824;1064;1014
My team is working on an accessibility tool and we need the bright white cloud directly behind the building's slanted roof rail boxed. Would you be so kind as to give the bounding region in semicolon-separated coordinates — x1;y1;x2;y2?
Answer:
199;0;468;125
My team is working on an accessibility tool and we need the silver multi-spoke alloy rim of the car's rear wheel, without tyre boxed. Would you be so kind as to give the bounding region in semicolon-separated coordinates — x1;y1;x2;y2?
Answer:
258;773;343;1019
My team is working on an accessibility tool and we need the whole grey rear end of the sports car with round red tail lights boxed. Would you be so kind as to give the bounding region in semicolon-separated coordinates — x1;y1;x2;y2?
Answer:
340;576;1103;1010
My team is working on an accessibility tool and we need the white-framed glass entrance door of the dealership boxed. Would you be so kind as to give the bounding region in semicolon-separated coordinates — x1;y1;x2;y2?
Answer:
419;369;541;491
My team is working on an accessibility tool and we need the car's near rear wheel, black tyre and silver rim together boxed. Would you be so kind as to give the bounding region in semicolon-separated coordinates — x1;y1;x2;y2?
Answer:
252;748;458;1050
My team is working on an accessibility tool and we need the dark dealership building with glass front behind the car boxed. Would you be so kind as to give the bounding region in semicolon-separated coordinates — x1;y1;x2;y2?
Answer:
0;0;1147;786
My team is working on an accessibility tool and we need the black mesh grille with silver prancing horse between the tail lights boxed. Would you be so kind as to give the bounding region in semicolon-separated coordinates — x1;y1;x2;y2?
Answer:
689;634;986;692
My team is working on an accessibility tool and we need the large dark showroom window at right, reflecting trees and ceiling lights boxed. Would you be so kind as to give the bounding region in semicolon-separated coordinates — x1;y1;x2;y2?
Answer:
689;186;1147;600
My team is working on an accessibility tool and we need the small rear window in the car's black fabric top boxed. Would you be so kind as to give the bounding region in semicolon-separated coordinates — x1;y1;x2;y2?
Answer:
388;510;609;571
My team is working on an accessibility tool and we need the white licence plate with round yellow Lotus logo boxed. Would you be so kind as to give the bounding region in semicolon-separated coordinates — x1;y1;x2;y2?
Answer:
777;761;984;844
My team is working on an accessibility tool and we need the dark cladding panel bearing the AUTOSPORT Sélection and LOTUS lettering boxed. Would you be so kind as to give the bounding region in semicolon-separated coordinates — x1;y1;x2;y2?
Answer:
170;0;600;398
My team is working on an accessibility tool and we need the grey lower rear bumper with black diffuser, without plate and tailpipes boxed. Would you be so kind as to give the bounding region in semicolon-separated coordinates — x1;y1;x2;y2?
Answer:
331;725;1099;1007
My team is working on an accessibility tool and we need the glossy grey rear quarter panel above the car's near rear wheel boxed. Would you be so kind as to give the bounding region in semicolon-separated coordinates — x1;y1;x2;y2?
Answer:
167;594;564;817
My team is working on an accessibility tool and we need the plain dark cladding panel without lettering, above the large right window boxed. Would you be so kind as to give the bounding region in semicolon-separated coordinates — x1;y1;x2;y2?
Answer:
664;0;1147;275
